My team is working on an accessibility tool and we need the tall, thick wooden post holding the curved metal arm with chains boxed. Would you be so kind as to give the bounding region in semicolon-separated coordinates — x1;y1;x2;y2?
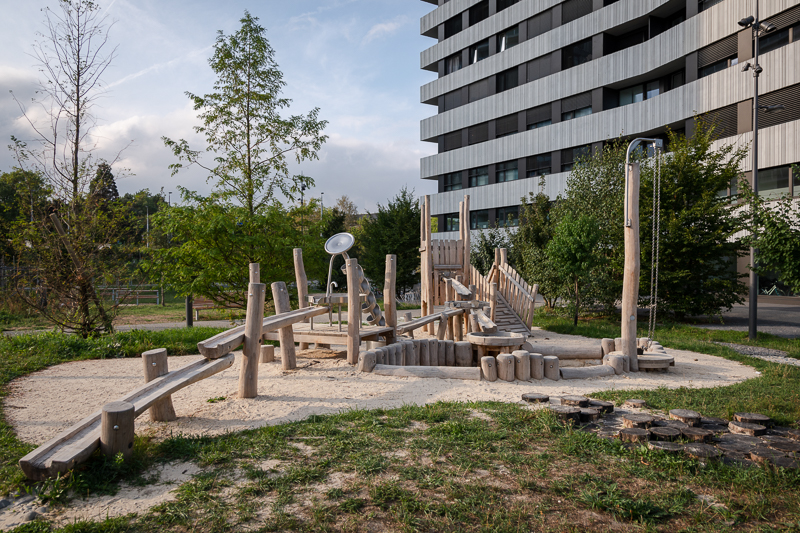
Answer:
622;163;641;372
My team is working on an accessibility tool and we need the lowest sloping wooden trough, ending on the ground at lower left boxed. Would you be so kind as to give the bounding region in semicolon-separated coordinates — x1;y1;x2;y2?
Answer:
19;354;235;481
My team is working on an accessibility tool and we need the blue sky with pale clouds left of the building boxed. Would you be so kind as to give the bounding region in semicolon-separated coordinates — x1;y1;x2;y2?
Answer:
0;0;436;212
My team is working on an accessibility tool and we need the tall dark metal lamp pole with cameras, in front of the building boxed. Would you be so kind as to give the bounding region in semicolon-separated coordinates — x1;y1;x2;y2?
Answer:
739;0;783;340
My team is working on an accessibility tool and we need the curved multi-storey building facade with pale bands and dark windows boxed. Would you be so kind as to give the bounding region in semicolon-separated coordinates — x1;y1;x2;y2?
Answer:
420;0;800;284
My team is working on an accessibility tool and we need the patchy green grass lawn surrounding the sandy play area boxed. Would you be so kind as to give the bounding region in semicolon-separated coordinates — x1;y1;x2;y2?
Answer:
0;317;800;532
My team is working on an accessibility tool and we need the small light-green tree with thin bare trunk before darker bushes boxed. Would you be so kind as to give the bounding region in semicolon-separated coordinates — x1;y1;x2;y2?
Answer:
546;213;600;326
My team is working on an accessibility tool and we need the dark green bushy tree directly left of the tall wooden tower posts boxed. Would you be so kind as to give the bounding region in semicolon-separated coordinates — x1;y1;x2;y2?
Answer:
356;187;420;295
